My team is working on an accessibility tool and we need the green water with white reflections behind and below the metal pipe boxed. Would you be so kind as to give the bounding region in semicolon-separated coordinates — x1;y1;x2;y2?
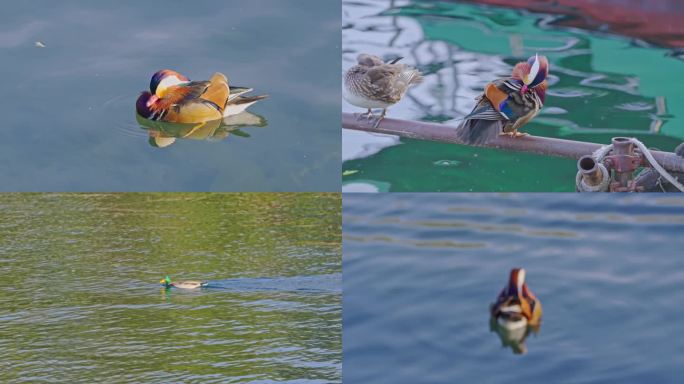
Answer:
342;0;684;192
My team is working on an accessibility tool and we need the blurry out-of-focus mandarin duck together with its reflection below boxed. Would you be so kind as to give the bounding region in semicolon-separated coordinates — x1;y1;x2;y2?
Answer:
489;268;542;354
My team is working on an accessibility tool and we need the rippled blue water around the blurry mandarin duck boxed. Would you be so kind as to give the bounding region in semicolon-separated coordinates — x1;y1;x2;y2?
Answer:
343;194;684;384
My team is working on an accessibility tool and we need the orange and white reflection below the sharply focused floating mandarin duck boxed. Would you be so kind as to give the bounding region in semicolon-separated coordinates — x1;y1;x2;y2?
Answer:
136;111;268;148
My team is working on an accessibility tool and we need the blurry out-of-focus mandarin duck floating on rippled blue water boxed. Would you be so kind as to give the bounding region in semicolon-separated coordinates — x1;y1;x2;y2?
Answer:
491;268;542;330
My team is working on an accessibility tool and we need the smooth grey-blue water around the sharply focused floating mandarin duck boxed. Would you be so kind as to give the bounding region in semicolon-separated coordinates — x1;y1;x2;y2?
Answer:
0;0;341;191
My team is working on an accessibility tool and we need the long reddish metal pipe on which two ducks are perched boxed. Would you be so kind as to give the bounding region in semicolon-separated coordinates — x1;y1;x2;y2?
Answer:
342;113;684;172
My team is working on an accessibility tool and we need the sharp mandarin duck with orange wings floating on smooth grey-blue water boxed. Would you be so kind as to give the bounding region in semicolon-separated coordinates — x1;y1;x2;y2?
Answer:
136;69;266;123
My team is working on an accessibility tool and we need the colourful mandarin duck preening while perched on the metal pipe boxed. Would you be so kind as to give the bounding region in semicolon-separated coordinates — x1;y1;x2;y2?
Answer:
456;55;549;144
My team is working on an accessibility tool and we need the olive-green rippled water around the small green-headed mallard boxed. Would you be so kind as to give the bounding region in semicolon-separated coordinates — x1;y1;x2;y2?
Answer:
0;194;342;383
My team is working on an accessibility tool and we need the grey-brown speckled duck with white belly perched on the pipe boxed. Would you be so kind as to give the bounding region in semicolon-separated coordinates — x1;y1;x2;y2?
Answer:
342;53;423;128
